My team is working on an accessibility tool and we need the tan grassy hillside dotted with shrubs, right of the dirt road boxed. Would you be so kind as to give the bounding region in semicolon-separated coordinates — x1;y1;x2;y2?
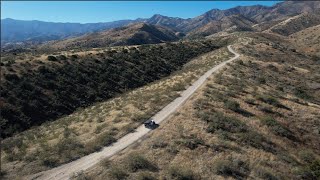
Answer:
75;34;320;179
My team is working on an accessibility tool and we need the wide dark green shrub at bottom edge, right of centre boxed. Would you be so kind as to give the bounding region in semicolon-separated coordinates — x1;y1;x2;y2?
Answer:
215;159;250;179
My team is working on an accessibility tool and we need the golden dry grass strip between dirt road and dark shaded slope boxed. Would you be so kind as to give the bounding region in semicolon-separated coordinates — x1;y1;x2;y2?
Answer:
2;44;230;178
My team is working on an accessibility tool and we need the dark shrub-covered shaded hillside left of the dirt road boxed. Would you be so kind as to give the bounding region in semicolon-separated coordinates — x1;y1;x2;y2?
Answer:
0;41;222;137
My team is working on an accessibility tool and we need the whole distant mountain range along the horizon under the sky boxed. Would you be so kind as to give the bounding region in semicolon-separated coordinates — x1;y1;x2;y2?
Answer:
1;1;320;45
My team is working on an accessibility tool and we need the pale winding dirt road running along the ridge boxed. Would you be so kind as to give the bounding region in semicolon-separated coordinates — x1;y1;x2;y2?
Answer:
27;45;240;180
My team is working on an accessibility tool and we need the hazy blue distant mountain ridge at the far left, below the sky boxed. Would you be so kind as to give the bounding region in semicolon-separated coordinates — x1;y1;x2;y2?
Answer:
1;19;141;44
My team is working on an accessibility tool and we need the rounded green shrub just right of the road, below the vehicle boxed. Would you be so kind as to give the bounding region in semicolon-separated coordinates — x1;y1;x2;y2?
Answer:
126;154;157;172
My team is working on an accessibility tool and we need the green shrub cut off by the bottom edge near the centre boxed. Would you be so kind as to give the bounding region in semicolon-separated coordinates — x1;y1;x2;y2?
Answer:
168;165;197;180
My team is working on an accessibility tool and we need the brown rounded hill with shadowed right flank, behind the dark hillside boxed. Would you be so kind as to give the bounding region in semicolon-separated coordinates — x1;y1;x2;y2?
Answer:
41;23;179;50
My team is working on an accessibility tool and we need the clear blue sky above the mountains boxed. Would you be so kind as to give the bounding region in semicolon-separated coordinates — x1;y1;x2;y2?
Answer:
1;1;279;23
